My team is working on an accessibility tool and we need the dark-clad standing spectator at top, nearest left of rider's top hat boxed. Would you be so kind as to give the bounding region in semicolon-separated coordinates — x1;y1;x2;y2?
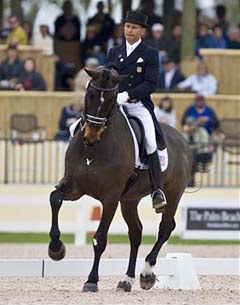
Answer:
88;1;115;51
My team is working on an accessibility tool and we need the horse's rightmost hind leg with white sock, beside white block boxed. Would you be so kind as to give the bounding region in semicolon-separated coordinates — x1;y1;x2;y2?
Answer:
140;192;181;290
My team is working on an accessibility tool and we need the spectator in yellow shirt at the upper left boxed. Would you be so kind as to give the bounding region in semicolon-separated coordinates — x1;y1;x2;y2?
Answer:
6;15;28;45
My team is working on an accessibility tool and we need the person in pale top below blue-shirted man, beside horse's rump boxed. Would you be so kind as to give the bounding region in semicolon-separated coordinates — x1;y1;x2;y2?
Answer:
182;116;213;186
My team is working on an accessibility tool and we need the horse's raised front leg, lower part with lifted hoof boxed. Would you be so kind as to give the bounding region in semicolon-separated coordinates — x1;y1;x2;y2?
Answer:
48;189;66;261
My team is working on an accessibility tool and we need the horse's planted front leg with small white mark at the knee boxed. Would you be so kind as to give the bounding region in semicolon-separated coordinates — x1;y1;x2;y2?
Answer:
83;201;118;292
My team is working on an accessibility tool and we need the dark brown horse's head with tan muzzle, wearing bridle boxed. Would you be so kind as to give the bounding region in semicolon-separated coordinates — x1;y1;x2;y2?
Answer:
84;67;122;144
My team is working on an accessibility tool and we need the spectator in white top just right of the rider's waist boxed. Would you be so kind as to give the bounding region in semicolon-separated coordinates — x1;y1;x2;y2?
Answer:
154;96;176;127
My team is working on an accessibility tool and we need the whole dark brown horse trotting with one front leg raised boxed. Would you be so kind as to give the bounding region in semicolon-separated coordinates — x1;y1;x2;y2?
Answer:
48;67;192;292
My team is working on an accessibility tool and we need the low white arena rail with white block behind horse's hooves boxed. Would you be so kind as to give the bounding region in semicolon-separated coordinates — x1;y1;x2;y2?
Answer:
0;253;240;289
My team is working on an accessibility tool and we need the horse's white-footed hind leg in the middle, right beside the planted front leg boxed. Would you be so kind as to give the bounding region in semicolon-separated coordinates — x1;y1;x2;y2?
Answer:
117;200;142;292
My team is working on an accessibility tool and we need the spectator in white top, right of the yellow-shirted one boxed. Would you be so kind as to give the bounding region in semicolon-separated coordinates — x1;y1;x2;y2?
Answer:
33;24;54;56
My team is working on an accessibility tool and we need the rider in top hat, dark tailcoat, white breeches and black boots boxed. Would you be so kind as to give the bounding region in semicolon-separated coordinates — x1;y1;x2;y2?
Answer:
108;11;167;210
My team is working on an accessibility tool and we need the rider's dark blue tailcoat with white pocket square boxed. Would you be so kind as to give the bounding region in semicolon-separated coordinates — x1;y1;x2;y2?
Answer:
107;42;164;142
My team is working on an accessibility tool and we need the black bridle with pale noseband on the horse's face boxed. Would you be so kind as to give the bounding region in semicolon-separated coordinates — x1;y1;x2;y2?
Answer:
85;81;118;128
